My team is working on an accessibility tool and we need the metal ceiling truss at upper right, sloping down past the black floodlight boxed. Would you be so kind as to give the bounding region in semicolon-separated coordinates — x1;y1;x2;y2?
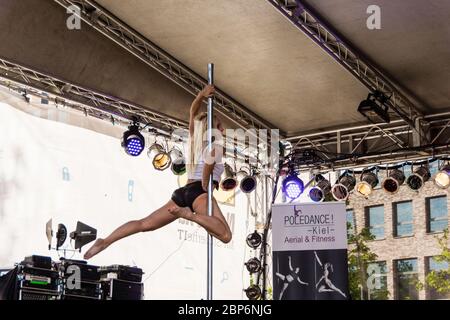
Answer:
267;0;426;138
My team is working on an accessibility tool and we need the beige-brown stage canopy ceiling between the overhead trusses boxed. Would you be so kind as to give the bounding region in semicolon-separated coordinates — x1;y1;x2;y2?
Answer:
0;0;450;135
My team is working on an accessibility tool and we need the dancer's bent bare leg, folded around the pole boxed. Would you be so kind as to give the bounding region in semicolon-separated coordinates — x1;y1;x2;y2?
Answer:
169;193;232;243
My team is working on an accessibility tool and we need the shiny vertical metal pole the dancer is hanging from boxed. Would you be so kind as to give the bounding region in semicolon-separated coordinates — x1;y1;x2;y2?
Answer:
206;63;214;300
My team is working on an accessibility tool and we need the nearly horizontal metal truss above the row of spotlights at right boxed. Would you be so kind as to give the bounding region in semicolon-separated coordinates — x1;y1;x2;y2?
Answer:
286;112;450;170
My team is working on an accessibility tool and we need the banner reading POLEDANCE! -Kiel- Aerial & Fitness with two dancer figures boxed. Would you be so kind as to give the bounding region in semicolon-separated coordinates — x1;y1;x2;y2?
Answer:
272;202;349;300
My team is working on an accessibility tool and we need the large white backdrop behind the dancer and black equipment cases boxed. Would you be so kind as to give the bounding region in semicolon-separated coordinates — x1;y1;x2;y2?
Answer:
0;92;254;299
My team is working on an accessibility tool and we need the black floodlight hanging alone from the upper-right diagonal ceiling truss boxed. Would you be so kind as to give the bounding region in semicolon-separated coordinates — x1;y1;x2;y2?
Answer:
358;91;391;123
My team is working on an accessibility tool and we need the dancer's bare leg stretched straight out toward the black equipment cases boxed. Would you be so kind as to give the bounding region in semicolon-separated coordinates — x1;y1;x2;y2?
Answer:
84;200;179;259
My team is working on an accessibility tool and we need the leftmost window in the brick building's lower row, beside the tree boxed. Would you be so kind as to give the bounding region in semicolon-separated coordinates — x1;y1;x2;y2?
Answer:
367;261;389;300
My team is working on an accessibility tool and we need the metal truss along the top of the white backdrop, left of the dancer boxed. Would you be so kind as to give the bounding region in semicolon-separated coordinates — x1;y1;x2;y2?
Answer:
0;57;188;133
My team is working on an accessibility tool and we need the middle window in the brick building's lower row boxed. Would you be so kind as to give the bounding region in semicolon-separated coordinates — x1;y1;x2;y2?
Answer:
394;259;419;300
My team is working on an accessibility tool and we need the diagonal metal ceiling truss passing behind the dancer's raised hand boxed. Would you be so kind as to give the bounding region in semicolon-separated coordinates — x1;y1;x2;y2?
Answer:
55;0;274;133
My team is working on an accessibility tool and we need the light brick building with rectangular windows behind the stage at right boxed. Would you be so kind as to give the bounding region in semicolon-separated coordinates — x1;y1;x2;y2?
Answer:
347;167;450;299
